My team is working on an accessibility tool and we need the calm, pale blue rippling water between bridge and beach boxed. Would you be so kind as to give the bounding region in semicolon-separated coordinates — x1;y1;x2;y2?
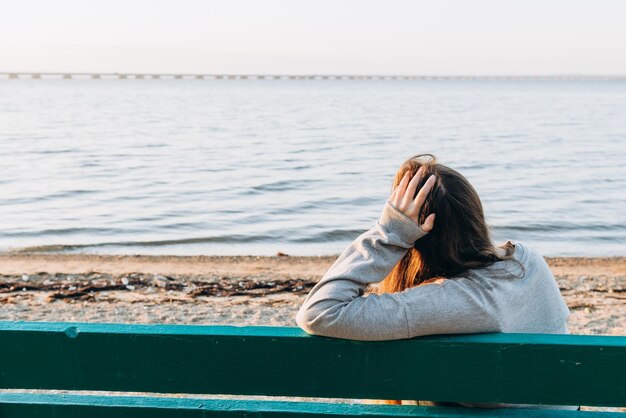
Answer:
0;80;626;256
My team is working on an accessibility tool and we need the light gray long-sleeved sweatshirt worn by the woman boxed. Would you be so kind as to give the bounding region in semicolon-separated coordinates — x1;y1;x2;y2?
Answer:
296;202;576;409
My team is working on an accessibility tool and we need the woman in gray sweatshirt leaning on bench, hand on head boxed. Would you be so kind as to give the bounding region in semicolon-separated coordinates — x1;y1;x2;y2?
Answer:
296;154;569;409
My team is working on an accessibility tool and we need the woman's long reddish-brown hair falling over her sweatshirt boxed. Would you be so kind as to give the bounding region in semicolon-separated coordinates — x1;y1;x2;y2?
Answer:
372;154;514;293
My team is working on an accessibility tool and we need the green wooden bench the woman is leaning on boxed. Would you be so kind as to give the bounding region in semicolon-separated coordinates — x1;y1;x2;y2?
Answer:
0;322;626;418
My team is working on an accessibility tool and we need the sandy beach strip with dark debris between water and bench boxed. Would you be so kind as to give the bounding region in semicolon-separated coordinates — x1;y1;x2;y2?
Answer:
0;253;626;335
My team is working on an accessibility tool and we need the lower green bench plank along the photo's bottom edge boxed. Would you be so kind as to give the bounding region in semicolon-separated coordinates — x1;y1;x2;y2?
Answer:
0;393;614;418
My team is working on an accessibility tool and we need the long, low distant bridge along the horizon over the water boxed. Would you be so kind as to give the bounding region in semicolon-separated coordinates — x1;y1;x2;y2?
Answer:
0;72;626;81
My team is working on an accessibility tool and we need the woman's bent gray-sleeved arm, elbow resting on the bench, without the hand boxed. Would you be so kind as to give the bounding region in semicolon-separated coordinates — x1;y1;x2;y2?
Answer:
296;203;502;341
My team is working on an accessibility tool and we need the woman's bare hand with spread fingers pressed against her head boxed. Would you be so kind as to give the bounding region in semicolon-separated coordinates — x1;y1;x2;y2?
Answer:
389;166;435;232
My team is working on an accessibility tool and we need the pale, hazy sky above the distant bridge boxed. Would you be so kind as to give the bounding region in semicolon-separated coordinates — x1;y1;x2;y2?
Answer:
0;0;626;75
